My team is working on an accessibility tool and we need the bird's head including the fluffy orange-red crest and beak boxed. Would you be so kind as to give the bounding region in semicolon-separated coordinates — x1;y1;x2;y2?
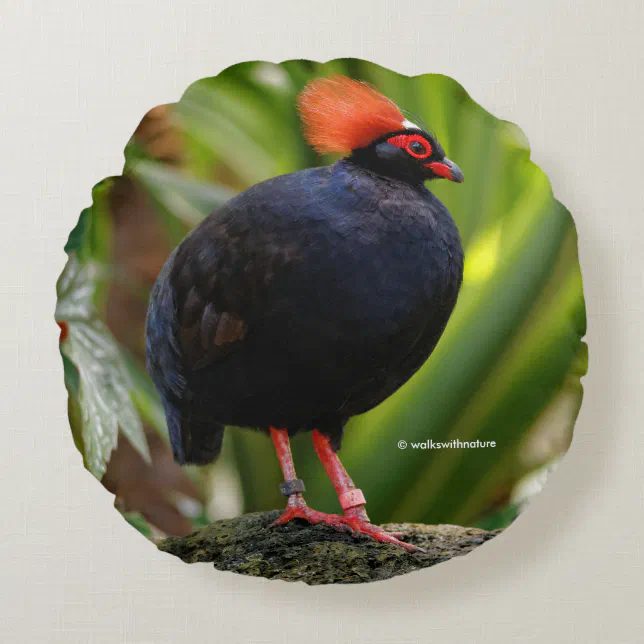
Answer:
298;76;463;183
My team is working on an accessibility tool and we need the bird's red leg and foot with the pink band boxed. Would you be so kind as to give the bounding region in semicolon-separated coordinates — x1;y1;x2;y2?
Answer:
313;429;419;552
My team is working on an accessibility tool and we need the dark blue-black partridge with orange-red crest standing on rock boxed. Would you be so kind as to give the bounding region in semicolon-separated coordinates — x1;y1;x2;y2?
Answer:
145;76;464;552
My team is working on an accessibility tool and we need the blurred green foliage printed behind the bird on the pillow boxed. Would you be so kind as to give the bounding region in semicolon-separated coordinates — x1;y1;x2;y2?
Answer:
56;59;587;534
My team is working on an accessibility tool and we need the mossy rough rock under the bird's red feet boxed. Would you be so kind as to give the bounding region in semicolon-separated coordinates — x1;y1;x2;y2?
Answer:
158;510;501;585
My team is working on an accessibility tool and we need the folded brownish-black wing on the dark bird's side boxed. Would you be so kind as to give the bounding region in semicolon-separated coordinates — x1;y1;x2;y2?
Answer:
170;191;306;371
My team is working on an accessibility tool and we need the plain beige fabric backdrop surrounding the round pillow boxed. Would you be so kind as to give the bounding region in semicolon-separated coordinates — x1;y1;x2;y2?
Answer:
0;0;644;644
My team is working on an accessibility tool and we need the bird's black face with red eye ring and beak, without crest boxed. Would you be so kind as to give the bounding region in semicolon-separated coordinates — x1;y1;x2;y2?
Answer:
350;129;463;184
